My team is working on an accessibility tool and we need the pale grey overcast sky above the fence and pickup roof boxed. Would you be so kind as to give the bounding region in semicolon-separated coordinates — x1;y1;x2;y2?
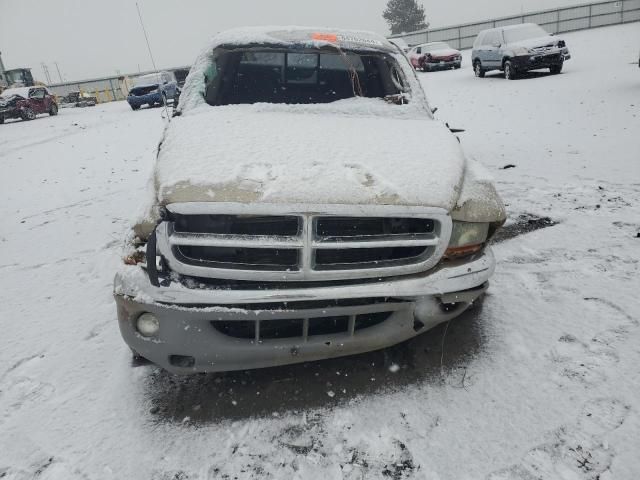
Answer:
0;0;582;82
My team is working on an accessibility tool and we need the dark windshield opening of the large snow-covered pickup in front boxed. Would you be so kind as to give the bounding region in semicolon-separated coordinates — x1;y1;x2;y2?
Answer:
205;49;405;105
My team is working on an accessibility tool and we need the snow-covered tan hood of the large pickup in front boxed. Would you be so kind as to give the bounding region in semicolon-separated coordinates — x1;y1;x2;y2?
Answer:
154;98;465;211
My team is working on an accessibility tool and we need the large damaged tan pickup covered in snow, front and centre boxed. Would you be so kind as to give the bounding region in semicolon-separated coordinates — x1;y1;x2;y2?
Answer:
114;27;505;373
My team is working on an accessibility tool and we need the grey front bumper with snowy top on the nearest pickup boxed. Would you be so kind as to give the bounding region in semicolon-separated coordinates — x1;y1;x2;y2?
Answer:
114;249;495;374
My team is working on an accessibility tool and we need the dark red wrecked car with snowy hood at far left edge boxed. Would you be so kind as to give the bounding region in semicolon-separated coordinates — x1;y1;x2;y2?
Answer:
0;86;58;124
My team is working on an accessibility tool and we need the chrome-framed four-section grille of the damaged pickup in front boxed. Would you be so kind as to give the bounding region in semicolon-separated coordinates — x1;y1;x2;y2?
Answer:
156;203;451;281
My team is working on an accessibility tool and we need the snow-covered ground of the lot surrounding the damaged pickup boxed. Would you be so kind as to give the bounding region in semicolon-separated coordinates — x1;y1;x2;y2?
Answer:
0;24;640;480
